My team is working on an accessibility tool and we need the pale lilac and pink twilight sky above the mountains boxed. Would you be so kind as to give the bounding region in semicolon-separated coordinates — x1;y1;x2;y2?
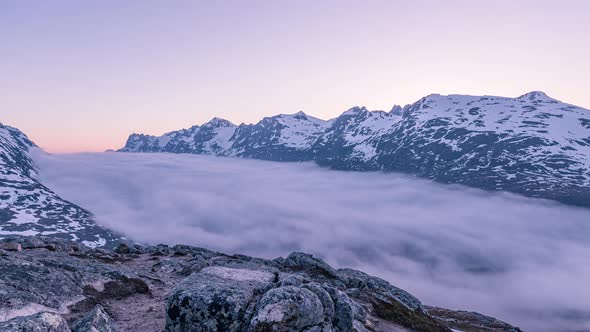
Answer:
0;0;590;152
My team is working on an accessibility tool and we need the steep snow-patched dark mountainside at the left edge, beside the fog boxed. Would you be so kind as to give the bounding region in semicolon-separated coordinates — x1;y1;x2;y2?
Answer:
0;123;121;247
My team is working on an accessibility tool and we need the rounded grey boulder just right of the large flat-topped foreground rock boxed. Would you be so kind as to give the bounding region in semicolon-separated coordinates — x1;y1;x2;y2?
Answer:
249;286;324;332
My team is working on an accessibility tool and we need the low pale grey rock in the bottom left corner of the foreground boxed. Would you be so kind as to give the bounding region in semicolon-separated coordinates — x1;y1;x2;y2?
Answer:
0;312;70;332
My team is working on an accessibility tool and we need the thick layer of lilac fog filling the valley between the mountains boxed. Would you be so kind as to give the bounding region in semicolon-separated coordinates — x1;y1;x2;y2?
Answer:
35;153;590;331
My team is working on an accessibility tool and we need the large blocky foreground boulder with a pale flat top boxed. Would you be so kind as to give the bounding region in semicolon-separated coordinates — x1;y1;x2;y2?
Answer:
166;266;275;332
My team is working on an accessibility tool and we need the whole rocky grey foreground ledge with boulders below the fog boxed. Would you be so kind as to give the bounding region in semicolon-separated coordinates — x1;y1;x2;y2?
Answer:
0;237;521;332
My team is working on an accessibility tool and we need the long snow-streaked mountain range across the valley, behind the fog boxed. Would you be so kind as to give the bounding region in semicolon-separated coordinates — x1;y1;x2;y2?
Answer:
120;91;590;206
